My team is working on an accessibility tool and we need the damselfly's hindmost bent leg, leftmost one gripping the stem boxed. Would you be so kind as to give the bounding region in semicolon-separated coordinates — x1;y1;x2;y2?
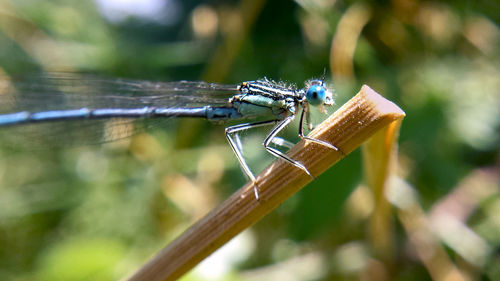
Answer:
226;120;278;201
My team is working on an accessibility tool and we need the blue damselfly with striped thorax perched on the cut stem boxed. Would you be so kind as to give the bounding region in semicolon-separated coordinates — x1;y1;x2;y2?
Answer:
0;74;340;199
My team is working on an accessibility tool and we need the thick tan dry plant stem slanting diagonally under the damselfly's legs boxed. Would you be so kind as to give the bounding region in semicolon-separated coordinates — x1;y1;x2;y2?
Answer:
129;85;405;281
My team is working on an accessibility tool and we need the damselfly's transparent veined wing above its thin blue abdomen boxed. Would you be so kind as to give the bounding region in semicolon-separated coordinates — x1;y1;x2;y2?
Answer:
0;73;237;113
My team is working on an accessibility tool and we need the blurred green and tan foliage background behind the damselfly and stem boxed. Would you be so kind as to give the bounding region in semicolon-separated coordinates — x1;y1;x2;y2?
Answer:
0;0;500;280
